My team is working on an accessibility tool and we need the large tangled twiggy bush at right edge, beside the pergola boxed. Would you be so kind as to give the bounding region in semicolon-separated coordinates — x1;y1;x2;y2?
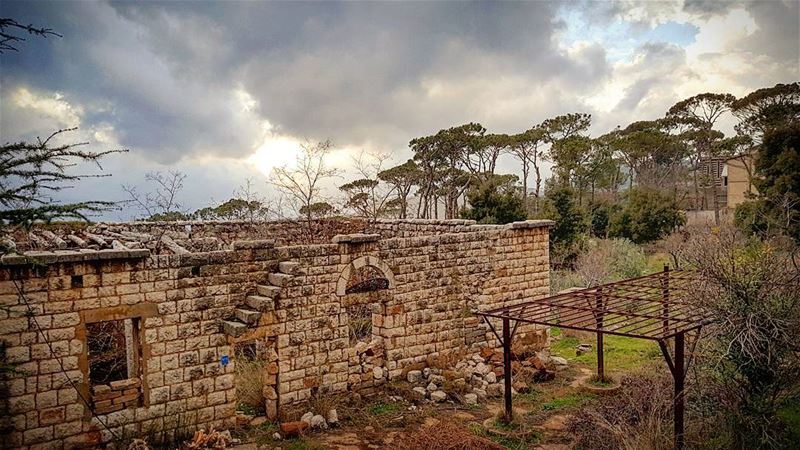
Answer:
686;227;800;449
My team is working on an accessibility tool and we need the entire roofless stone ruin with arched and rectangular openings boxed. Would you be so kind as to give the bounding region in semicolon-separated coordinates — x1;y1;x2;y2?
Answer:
0;219;552;448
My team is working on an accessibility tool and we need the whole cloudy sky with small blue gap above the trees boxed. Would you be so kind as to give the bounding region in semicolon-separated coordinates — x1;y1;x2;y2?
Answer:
0;0;800;219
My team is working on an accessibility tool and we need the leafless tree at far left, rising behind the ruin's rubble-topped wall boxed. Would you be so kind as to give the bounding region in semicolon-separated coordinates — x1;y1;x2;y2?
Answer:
122;170;187;221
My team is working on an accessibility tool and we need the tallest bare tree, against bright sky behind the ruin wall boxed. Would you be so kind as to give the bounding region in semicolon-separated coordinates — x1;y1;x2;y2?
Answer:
268;141;339;226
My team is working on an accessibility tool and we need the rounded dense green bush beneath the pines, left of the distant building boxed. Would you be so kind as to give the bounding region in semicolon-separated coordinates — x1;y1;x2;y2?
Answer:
608;188;686;244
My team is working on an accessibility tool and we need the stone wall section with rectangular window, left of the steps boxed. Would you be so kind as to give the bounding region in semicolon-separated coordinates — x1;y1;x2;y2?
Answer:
0;243;277;448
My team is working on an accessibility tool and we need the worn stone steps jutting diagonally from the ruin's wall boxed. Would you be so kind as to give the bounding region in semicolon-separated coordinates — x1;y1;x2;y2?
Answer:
220;261;300;337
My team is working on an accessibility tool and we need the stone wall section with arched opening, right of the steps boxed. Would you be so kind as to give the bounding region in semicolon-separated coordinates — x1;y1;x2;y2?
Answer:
278;221;550;405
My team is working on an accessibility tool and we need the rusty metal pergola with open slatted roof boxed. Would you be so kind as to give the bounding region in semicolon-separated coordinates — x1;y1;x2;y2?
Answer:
477;266;712;449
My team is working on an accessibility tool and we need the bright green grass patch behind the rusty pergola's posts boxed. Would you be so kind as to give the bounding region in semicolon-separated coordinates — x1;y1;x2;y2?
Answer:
550;328;661;371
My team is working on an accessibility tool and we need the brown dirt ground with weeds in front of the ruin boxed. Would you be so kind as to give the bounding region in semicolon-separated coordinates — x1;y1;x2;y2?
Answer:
228;364;598;450
